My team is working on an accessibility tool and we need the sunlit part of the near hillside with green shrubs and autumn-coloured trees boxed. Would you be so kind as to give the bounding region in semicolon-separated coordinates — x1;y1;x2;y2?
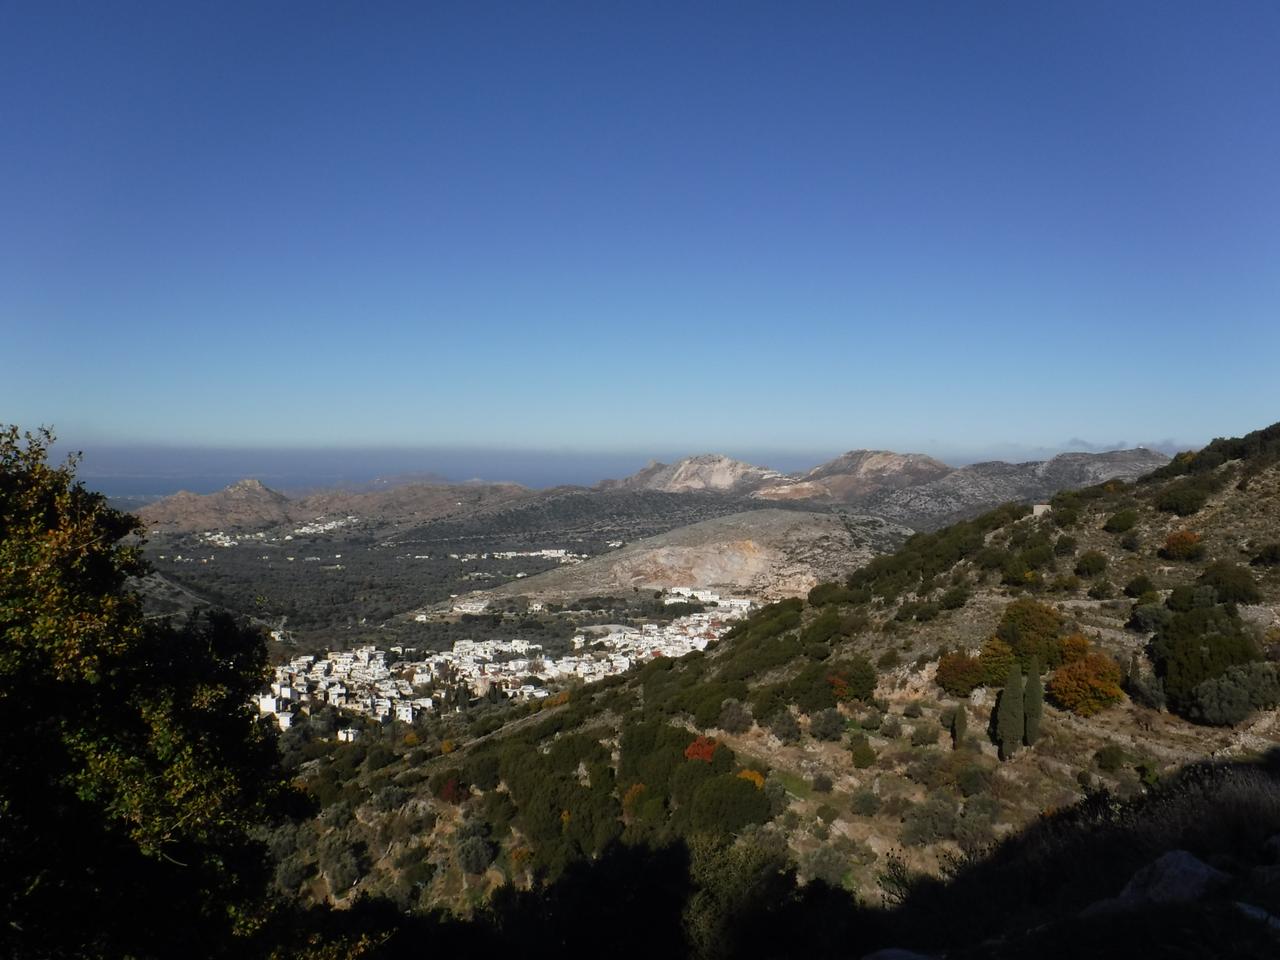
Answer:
267;431;1280;947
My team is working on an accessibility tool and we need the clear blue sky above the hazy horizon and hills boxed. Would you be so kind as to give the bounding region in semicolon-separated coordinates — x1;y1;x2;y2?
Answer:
0;0;1280;463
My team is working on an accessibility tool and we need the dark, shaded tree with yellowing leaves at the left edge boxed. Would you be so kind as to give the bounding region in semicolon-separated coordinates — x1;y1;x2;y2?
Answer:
0;428;283;957
